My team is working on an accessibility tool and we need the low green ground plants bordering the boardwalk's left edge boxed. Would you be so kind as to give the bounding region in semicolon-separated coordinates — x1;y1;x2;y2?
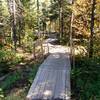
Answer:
0;62;41;100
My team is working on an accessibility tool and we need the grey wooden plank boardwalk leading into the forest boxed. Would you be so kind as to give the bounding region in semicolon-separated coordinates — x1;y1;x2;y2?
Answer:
27;39;70;100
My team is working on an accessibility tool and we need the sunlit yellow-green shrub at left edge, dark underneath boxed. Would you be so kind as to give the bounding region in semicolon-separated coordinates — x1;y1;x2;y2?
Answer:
0;49;22;76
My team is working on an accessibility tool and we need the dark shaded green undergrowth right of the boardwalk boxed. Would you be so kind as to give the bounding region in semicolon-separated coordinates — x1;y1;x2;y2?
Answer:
72;57;100;100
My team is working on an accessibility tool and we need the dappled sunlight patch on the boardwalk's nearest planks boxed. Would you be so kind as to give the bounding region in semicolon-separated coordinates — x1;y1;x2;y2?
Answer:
27;79;70;100
